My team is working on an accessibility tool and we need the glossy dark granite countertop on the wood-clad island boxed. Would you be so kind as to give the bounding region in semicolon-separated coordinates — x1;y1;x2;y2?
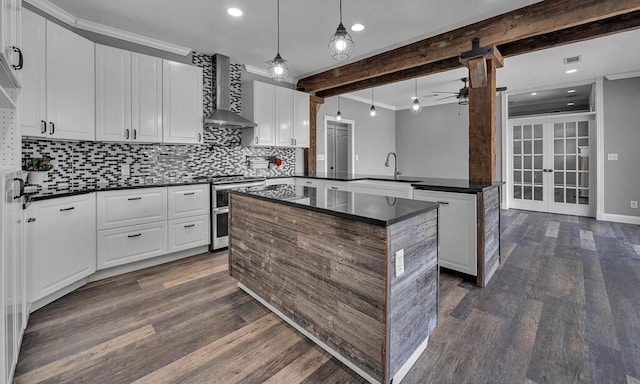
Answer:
231;185;438;227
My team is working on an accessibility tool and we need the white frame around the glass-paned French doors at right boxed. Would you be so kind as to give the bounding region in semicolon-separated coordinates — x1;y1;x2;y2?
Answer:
503;112;603;217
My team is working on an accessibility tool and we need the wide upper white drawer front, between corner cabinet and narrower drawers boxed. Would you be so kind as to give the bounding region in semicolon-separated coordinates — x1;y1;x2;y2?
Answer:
97;187;167;230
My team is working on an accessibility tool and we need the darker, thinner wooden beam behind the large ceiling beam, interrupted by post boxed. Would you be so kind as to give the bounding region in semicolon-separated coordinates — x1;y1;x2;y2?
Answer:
316;11;640;97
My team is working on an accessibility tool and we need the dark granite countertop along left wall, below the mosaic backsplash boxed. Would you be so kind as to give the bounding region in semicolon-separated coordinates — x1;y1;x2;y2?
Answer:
24;179;208;208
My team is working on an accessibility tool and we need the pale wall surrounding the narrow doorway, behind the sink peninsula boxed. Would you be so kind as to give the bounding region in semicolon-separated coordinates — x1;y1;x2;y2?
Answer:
316;97;402;175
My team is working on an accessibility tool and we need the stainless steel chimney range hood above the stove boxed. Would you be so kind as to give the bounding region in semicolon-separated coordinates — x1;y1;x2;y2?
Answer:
204;54;257;128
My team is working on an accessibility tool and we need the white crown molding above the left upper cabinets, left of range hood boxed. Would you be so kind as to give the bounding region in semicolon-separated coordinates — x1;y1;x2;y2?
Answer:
25;0;192;56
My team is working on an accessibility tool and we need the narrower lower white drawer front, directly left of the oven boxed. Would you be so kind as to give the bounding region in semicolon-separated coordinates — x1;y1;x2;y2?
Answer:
168;215;210;253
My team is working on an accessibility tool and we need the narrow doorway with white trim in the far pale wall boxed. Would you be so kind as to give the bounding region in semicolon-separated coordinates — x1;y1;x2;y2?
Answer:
323;115;355;177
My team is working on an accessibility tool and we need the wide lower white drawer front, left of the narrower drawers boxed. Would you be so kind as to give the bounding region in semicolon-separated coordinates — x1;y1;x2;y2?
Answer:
98;222;167;269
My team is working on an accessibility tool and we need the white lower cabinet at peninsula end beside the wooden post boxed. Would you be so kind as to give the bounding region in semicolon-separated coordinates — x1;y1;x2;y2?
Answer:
413;190;478;276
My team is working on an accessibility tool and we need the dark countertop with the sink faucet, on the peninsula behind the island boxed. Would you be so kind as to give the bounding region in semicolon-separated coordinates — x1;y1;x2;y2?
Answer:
295;173;504;193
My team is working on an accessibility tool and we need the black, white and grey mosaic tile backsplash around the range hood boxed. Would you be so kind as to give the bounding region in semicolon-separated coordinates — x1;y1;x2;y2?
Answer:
22;54;296;189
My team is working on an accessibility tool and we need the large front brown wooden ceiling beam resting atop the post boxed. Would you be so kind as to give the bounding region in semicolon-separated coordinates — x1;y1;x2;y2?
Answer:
297;0;640;93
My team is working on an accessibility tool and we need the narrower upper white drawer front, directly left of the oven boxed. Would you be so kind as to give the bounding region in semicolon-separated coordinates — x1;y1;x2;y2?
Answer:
167;184;210;219
